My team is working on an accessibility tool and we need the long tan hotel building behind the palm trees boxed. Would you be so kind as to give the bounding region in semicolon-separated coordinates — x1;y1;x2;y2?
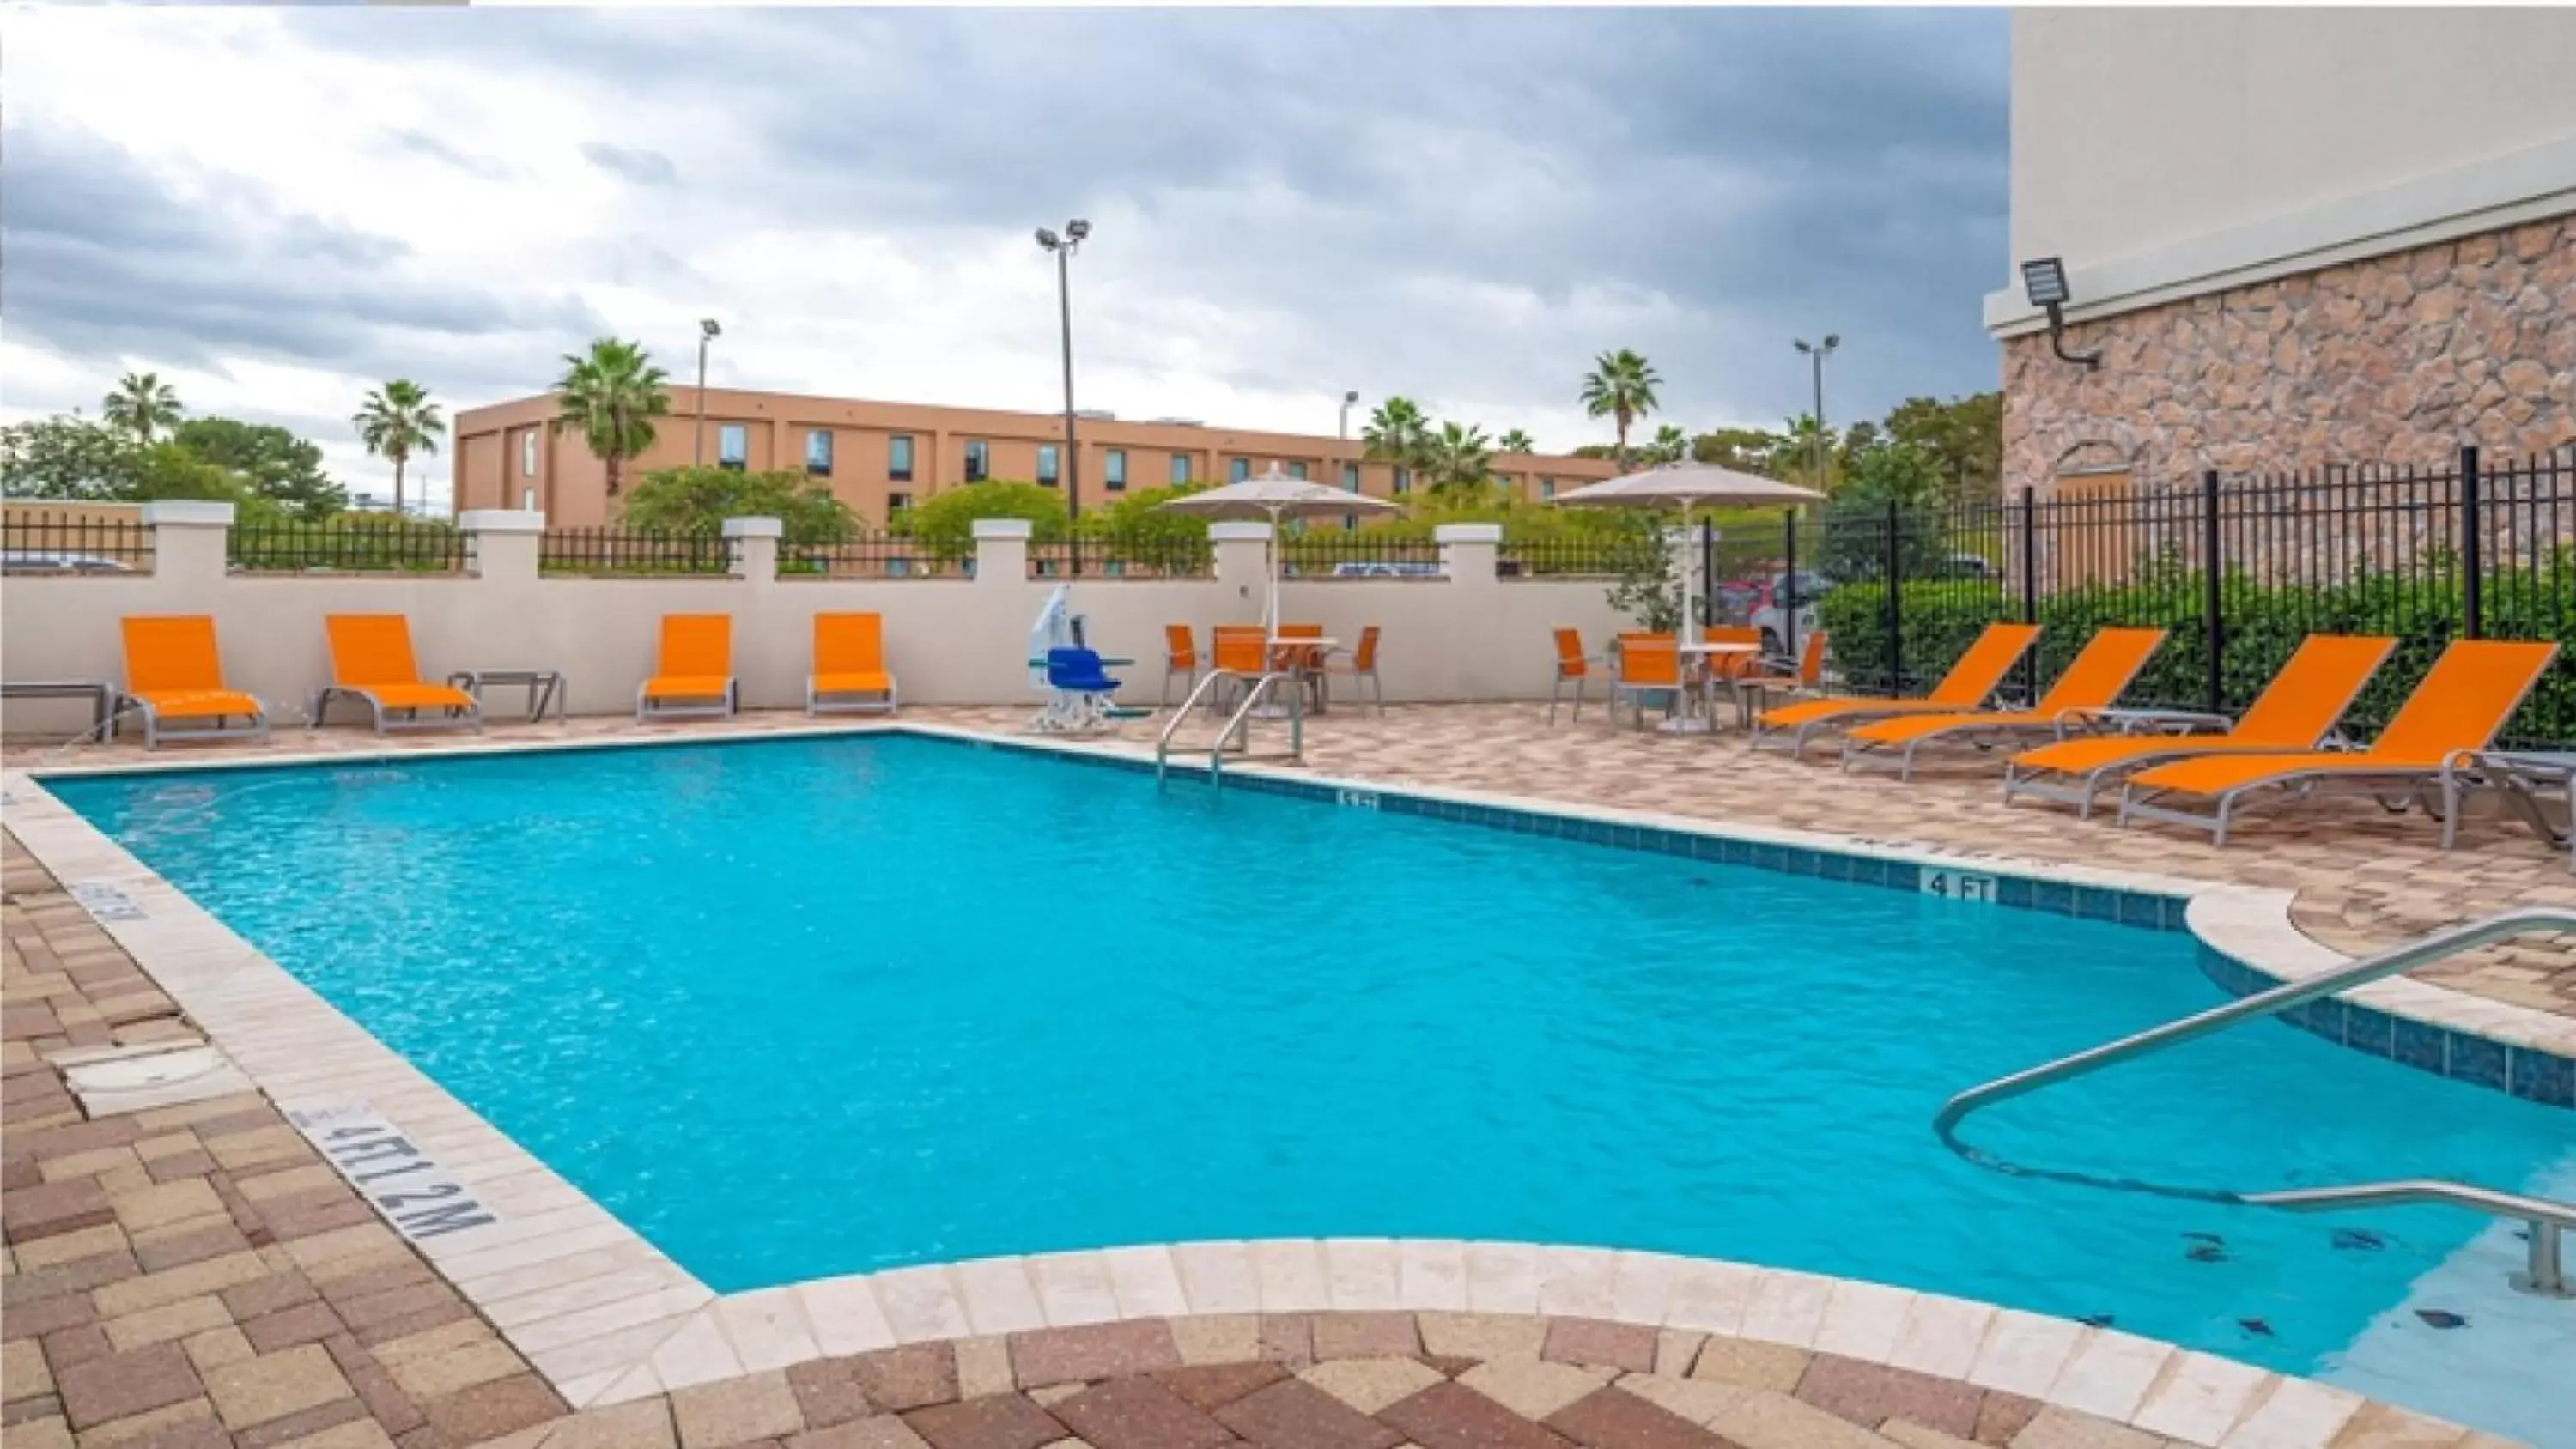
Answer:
451;389;1618;528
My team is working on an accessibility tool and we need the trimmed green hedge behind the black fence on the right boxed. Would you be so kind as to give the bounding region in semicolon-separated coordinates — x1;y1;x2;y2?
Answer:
1816;569;2576;749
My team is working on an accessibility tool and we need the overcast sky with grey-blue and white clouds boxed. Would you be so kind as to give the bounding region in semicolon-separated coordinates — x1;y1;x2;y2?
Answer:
0;8;2007;500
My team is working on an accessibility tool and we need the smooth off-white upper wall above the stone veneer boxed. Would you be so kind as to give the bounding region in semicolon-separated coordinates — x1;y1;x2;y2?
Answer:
1986;5;2576;330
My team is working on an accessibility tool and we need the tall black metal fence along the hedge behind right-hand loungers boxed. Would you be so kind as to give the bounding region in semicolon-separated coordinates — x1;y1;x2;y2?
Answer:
1762;448;2576;749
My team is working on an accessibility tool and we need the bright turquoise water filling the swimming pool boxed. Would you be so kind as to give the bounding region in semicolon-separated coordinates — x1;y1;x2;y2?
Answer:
54;738;2576;1408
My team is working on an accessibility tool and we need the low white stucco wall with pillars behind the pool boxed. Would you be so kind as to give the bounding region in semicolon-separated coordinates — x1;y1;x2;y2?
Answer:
0;514;1628;733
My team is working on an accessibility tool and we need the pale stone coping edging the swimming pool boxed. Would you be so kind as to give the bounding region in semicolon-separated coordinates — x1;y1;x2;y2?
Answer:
0;721;2548;1446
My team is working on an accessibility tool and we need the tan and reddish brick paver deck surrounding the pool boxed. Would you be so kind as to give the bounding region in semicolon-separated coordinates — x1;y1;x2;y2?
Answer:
0;708;2545;1449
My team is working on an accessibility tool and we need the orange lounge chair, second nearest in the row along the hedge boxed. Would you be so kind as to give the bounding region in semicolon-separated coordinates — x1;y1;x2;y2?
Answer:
2004;634;2398;818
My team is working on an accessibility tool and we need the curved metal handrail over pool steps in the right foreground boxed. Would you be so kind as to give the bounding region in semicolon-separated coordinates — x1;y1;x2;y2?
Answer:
1932;906;2576;1297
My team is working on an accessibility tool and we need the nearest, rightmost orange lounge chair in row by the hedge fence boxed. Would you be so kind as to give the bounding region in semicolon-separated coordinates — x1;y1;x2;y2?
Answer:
2120;639;2558;844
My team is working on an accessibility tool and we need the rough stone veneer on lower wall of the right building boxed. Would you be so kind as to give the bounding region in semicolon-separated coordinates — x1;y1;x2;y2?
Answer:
2004;214;2576;492
